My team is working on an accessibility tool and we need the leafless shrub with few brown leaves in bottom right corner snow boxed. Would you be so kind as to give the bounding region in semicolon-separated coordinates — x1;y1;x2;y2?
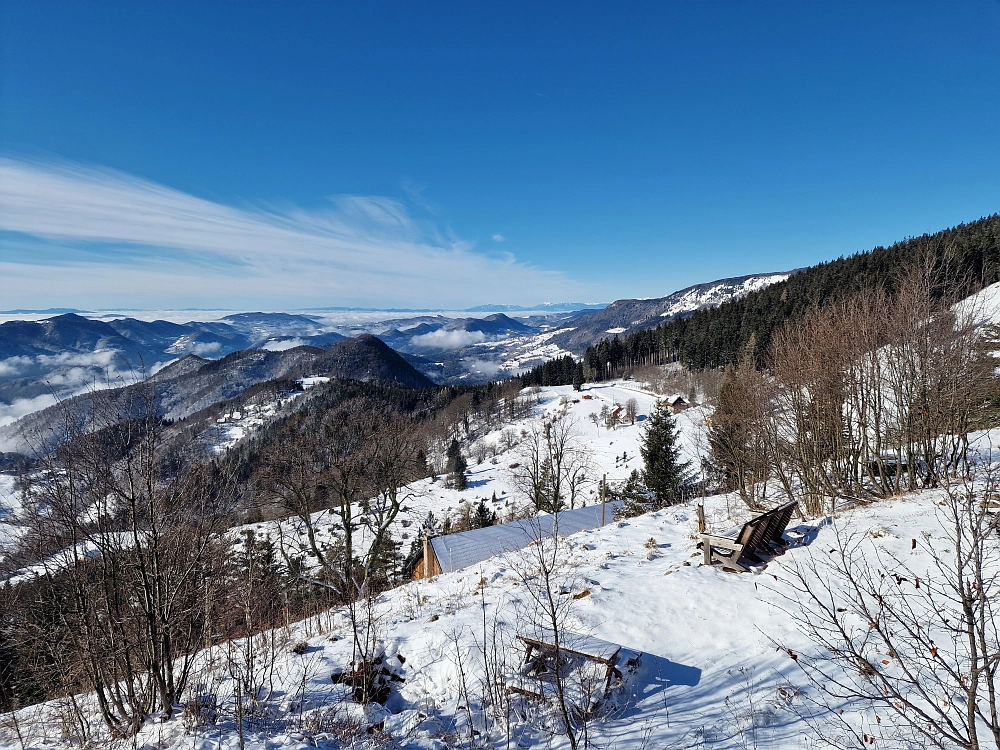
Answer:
776;474;1000;750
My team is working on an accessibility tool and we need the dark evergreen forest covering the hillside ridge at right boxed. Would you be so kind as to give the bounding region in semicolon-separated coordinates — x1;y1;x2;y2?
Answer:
584;214;1000;377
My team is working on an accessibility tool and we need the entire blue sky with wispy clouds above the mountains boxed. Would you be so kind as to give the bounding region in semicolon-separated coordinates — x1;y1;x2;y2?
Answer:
0;0;1000;309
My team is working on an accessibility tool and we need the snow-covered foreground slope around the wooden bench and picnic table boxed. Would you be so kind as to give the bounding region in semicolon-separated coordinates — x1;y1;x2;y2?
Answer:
0;470;984;750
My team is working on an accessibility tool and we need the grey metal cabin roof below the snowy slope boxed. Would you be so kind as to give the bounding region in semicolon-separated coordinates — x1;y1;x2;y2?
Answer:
430;503;615;573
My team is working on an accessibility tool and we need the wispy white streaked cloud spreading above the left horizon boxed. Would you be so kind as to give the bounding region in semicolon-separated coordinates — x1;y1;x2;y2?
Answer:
0;158;589;309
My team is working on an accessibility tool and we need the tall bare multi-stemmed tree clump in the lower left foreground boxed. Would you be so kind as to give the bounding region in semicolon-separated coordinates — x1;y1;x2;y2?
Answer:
14;385;232;737
